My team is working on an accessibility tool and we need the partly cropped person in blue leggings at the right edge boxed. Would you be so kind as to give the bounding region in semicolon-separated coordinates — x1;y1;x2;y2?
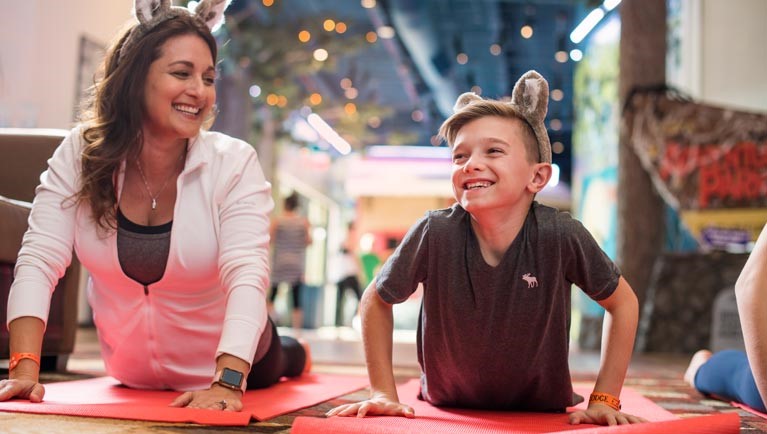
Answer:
684;226;767;412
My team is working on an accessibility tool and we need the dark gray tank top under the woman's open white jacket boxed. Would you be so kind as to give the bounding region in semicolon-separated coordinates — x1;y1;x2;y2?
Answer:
117;208;173;286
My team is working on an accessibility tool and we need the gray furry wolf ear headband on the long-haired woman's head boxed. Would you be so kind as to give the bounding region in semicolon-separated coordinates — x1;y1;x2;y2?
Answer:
118;0;232;61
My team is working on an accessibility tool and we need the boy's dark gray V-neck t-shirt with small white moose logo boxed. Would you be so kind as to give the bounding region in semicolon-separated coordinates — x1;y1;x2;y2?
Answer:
376;202;620;411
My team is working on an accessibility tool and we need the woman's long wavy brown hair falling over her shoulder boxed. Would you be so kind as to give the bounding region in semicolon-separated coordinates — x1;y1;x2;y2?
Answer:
74;15;218;230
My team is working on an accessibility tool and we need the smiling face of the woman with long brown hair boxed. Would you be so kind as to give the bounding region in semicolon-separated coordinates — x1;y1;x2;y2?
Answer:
143;35;216;140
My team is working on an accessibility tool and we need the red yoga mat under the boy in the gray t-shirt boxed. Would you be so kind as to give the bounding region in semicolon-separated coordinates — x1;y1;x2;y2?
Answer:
291;380;740;434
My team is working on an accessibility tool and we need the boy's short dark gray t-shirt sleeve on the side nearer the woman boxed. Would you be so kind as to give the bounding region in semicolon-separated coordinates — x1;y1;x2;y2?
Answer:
376;215;429;304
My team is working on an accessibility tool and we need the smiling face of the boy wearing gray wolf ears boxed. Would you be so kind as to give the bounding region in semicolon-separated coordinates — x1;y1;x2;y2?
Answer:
452;116;537;213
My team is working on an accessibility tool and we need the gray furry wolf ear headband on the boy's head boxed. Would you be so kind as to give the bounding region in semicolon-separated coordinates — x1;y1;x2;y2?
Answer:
453;70;551;163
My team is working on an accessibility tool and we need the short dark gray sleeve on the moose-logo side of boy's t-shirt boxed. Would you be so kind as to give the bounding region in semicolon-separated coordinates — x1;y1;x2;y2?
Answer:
561;214;621;301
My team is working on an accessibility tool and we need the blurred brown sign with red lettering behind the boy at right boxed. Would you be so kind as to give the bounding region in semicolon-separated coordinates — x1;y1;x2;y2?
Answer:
624;89;767;247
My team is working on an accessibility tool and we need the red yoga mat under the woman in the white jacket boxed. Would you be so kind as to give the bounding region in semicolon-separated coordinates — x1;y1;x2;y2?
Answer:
0;374;368;425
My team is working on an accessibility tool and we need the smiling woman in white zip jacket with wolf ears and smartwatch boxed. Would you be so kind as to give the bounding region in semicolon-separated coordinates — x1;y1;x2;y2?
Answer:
0;0;307;411
